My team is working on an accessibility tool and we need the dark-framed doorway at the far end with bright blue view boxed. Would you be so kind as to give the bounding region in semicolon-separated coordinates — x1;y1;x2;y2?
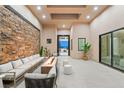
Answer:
57;35;70;56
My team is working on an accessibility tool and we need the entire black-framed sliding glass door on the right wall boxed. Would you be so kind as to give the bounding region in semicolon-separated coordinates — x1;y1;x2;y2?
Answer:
99;28;124;71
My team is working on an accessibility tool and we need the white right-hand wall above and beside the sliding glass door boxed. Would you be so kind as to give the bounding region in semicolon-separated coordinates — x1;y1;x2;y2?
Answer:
90;5;124;61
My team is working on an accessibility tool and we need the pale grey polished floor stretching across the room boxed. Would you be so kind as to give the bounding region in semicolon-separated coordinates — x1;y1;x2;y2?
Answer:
17;56;124;88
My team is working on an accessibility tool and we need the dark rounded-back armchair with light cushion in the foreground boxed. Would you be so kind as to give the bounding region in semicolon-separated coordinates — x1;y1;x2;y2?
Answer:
25;73;55;88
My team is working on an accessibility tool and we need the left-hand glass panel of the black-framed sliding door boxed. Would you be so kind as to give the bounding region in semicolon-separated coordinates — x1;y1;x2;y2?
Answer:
101;34;111;65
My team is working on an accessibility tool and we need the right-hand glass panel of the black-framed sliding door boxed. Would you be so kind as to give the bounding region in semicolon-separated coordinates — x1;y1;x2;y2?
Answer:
113;30;124;70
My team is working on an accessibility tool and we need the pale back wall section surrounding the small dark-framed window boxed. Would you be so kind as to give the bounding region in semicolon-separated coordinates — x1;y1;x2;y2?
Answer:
70;24;90;58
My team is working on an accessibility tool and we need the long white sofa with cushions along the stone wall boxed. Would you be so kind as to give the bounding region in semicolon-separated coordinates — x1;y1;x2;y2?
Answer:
0;54;44;85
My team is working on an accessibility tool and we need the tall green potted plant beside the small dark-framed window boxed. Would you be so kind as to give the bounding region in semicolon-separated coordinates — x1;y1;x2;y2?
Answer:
83;42;91;60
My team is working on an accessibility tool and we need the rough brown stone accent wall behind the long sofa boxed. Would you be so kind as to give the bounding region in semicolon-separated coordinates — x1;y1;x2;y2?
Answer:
0;6;40;64
